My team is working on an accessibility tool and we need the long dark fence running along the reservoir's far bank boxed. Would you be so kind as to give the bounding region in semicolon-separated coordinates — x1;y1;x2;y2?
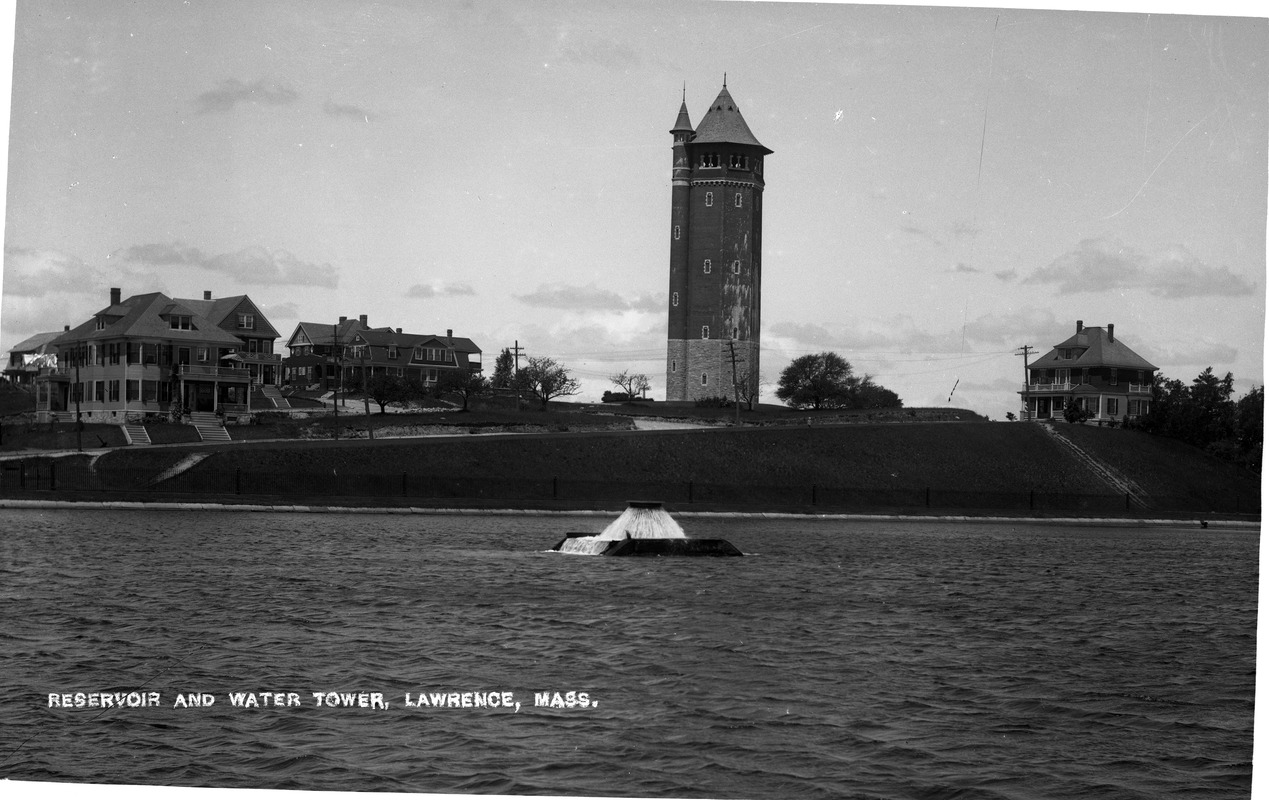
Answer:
0;460;1260;516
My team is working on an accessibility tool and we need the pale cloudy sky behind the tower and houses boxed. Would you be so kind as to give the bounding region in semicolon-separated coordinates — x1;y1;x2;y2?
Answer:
0;0;1269;419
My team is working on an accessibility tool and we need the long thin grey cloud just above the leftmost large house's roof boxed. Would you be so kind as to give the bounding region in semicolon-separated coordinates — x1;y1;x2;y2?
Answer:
110;243;339;288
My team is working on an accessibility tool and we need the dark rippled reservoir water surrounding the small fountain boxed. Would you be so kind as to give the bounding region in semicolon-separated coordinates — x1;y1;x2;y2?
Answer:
0;510;1259;800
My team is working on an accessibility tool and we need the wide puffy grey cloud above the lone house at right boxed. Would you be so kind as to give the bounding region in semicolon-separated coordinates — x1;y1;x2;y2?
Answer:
1023;239;1256;298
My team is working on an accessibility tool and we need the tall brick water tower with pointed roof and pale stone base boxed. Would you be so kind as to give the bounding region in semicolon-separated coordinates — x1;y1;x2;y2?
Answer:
665;80;772;400
